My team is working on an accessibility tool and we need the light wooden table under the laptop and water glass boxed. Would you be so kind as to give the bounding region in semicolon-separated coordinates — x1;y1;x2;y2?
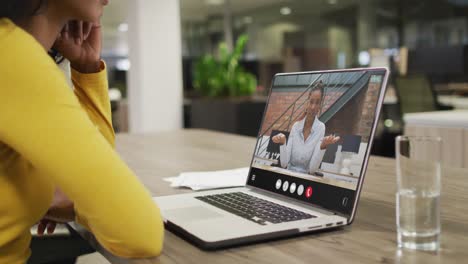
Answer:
77;130;468;264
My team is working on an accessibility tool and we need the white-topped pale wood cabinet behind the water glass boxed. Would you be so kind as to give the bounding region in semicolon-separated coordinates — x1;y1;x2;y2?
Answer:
404;110;468;168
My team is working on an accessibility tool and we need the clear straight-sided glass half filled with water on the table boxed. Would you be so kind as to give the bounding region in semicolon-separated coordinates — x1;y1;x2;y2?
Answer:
396;136;442;251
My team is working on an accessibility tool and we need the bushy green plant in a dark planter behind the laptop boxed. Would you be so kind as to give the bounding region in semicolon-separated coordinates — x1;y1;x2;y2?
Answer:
190;35;265;136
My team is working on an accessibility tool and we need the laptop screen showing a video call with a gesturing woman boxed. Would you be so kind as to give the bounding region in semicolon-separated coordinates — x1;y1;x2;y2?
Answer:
247;68;387;215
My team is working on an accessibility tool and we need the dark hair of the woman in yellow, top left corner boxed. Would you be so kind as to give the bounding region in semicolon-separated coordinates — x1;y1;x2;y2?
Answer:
0;0;47;22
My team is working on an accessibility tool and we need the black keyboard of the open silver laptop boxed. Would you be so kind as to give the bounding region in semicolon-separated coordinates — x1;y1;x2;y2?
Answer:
195;192;316;225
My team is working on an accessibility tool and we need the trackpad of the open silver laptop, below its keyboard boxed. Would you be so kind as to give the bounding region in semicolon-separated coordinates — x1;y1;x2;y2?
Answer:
164;206;223;222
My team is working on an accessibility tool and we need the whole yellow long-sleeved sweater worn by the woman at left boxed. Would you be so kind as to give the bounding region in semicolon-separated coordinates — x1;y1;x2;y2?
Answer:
0;19;164;264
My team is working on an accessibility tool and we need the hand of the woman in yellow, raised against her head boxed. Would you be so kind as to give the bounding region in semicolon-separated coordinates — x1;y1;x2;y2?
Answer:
54;20;102;73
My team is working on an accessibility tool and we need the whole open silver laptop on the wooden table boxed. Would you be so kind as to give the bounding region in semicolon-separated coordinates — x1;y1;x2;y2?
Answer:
154;68;389;250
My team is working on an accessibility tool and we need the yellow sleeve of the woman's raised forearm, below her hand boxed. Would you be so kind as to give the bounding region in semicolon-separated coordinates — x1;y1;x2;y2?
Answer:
71;61;115;147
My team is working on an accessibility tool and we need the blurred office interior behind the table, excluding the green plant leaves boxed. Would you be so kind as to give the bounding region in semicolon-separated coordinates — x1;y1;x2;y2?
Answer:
102;0;468;156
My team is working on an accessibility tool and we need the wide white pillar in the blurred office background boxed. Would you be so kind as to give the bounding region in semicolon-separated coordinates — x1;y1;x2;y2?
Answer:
128;0;182;132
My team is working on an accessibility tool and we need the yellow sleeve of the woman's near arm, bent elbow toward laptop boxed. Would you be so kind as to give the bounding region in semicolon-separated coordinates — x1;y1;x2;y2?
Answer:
0;31;164;258
